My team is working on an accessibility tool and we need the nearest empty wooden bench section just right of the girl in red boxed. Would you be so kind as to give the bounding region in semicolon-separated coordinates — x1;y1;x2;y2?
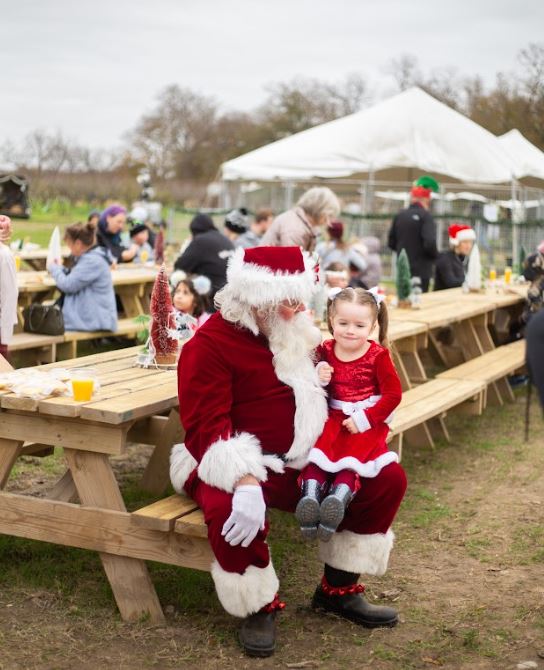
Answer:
390;379;486;458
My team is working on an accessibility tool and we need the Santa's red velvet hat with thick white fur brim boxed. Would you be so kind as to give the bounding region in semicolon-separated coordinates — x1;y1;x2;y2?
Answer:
225;247;317;307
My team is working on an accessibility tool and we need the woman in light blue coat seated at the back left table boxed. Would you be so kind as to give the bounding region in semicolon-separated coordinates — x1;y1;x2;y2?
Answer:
48;223;117;332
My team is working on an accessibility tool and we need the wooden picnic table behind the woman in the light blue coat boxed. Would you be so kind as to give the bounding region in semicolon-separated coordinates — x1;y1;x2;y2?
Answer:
17;265;158;324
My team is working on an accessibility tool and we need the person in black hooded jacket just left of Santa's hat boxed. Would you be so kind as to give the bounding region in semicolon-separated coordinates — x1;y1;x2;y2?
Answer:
174;214;234;300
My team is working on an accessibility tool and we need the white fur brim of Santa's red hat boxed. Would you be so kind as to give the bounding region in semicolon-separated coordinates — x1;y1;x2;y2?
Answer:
227;248;316;307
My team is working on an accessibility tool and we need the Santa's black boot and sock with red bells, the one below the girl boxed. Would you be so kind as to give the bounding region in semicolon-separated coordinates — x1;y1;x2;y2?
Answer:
312;565;399;628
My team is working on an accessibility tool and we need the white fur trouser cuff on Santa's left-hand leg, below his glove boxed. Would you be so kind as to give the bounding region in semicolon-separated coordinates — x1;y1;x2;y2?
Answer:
212;560;280;618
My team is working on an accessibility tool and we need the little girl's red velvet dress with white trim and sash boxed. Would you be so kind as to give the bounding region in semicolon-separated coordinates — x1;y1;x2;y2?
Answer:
309;340;402;477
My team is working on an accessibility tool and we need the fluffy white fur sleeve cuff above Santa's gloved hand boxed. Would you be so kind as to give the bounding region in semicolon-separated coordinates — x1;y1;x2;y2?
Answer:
198;433;267;493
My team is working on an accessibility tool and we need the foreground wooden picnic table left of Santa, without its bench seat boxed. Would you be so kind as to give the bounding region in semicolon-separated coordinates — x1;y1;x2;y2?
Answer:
0;347;212;621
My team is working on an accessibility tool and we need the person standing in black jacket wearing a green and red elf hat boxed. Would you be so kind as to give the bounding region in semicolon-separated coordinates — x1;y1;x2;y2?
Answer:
388;182;438;293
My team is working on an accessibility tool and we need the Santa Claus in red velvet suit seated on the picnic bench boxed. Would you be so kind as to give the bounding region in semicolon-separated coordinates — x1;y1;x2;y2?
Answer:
170;247;406;656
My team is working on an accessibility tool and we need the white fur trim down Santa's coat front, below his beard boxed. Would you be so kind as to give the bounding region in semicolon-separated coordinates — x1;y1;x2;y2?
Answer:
273;355;328;468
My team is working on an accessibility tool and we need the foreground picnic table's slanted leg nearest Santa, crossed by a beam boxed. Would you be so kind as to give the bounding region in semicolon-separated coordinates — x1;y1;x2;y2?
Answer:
64;449;164;622
